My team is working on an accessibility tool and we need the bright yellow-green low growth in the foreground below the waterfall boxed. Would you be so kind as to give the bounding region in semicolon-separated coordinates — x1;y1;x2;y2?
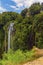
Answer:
0;49;35;65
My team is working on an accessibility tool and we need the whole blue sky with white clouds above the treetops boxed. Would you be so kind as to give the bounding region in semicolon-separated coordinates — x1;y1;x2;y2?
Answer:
0;0;43;13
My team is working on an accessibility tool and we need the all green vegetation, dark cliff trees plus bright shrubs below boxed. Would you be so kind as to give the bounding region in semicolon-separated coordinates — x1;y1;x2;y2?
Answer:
0;3;43;65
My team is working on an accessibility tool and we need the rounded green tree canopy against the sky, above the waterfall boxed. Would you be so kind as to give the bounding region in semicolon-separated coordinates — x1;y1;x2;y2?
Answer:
0;12;19;25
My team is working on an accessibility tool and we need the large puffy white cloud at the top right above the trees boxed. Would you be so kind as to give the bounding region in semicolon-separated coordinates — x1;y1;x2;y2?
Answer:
12;0;43;8
